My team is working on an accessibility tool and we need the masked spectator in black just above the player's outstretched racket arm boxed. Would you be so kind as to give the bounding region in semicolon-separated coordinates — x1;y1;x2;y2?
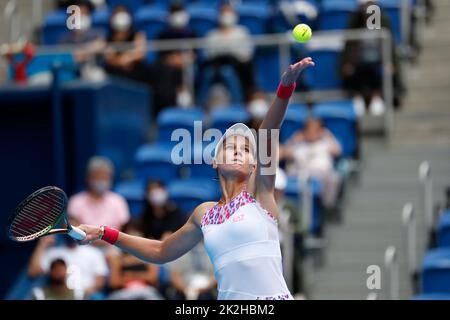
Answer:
141;181;185;239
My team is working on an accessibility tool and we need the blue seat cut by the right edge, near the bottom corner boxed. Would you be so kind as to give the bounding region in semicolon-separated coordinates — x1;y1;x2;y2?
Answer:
421;248;450;293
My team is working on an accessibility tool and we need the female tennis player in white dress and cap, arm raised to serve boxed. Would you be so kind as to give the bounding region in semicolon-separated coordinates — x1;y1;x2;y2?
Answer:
79;58;314;300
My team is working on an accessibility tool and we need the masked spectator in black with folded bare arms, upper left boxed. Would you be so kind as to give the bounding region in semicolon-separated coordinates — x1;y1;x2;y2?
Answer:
104;5;150;83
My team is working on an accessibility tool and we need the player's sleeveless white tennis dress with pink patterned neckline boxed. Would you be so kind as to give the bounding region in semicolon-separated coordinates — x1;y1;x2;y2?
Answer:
201;190;293;300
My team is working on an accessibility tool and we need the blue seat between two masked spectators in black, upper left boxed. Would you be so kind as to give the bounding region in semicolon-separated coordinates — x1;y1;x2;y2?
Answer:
135;5;168;39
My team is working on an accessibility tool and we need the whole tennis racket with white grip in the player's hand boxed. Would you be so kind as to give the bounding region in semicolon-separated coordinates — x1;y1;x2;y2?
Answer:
8;187;86;242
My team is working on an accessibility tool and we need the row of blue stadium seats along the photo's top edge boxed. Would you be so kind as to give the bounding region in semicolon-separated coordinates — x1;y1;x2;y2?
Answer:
42;0;413;45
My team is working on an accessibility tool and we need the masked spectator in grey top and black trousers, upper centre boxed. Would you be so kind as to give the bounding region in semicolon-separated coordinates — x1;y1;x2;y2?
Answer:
204;3;254;100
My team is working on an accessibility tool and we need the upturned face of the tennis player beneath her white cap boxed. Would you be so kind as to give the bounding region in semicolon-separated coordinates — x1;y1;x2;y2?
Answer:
217;135;256;176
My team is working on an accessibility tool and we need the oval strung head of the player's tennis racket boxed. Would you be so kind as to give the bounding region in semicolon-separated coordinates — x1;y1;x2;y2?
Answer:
10;192;67;240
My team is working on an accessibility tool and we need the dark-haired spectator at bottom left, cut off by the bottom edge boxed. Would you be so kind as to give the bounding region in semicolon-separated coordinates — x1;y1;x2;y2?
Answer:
32;258;76;300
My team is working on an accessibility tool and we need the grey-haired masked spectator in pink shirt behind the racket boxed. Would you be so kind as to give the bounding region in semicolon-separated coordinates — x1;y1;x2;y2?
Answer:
67;156;130;230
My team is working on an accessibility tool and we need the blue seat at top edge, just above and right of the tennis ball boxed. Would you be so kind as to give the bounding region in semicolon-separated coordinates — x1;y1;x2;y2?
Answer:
318;0;357;30
